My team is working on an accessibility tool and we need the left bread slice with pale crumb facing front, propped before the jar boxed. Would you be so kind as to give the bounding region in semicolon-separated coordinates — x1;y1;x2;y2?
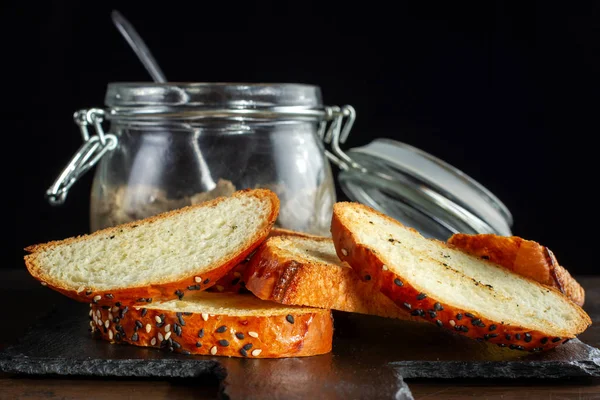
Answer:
24;189;279;304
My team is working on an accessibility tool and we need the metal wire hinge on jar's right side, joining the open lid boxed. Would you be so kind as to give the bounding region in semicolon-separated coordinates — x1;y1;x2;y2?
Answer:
319;105;365;171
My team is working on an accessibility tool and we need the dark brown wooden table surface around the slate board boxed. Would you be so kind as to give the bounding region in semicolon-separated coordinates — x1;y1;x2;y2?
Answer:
0;269;600;399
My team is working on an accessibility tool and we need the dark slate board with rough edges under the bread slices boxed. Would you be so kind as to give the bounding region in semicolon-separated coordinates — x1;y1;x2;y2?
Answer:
0;301;600;399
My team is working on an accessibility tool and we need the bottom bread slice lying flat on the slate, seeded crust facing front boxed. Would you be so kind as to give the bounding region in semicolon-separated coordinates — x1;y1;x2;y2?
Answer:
90;291;333;358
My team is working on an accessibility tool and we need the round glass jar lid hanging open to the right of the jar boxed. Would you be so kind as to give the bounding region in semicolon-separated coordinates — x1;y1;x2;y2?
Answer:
337;139;513;241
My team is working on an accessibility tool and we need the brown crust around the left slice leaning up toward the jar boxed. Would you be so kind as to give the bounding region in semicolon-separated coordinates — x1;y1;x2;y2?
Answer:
24;189;279;305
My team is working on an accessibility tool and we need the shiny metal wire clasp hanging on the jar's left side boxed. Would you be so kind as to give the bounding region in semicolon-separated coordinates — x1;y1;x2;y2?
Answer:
46;108;117;206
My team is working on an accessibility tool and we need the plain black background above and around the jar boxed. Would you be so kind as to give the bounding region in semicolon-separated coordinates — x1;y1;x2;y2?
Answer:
5;1;600;274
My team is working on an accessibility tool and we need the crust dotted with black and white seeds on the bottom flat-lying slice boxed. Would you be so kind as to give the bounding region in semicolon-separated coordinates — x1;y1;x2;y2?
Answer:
90;298;333;358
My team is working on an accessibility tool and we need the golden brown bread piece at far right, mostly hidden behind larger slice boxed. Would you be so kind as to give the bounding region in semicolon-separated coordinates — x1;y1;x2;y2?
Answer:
448;233;585;306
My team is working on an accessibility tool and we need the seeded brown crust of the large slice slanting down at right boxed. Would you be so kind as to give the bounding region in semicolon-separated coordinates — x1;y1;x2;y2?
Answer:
331;202;591;352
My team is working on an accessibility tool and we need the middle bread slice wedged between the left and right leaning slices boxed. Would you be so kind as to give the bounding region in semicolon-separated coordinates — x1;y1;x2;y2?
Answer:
243;235;421;321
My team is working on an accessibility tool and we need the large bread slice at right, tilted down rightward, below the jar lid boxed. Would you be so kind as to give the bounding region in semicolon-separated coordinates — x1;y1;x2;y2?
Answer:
331;202;591;351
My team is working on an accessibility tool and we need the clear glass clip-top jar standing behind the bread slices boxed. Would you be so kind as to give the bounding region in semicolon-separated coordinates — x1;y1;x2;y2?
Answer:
47;83;354;235
